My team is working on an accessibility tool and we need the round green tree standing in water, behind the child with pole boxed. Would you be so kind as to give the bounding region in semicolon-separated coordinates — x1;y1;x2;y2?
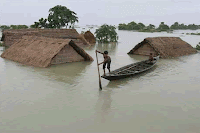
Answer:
95;24;118;43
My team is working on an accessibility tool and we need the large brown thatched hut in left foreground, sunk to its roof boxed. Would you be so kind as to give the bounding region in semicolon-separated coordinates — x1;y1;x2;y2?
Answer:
1;36;93;67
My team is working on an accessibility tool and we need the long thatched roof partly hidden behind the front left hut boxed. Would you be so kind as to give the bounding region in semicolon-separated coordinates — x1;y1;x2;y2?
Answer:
1;29;90;47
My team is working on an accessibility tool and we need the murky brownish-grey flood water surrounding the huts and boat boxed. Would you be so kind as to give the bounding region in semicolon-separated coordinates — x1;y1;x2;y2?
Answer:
0;30;200;133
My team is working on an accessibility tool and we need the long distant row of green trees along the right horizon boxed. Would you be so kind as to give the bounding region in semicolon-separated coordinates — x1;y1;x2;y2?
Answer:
118;21;200;32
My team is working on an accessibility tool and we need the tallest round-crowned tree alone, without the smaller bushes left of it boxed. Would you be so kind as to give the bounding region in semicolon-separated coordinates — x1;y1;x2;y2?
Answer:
48;5;78;28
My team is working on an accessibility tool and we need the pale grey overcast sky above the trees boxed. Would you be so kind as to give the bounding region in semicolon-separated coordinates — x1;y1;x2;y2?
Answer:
0;0;200;26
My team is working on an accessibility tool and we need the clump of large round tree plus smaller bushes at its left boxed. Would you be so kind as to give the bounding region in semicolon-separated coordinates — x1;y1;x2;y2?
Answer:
31;5;78;29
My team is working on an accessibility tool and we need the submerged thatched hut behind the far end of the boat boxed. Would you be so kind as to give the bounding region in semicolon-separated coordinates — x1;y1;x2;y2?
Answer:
128;37;197;58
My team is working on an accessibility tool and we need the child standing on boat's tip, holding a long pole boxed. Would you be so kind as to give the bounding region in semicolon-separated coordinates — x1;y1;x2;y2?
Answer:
96;50;111;75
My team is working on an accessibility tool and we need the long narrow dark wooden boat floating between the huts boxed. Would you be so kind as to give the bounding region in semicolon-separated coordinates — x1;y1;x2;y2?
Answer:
101;56;159;80
